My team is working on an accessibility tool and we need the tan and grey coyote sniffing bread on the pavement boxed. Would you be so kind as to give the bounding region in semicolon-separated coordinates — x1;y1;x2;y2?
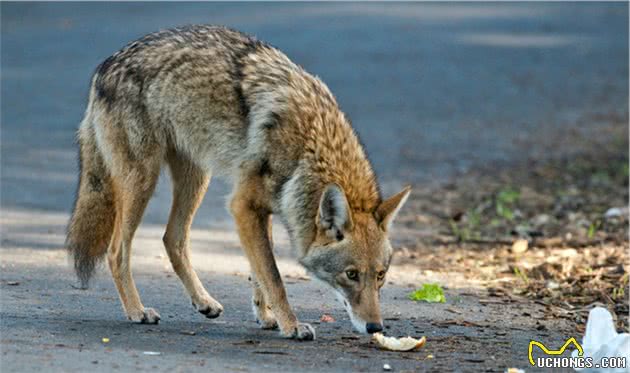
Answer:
67;26;410;340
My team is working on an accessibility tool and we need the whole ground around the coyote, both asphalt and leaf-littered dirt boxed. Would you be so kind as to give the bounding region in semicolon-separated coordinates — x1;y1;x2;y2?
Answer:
0;3;629;373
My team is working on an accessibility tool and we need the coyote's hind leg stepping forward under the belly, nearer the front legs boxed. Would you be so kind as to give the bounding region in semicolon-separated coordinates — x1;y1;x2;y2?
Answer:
163;152;223;318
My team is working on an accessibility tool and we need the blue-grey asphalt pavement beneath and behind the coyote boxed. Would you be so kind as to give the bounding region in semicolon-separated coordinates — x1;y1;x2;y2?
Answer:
0;3;628;372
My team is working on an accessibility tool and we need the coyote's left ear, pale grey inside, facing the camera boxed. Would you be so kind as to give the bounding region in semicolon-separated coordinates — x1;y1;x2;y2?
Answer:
316;184;352;241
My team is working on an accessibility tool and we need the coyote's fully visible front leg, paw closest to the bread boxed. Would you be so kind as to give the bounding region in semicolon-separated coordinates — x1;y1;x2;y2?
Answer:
230;182;315;340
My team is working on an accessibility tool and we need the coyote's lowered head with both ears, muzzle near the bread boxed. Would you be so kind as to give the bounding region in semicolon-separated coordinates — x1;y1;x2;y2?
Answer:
300;184;410;333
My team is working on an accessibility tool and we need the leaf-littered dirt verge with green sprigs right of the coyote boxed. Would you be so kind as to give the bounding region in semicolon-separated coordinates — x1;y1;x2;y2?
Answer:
400;117;629;332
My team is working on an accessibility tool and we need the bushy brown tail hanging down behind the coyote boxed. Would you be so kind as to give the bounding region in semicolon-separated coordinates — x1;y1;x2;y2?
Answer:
66;122;116;288
